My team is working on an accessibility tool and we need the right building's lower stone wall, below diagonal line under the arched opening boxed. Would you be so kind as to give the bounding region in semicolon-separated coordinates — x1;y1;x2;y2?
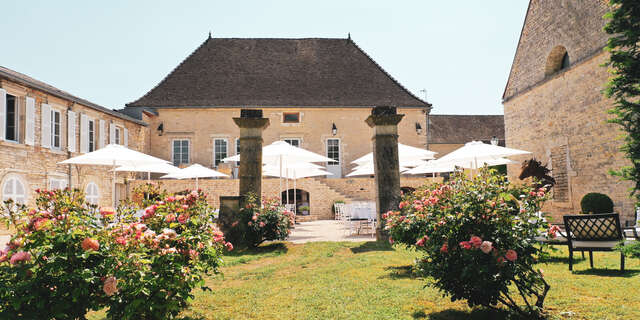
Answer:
504;53;635;224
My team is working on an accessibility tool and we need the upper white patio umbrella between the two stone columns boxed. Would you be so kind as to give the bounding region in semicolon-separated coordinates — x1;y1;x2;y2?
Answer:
222;141;333;199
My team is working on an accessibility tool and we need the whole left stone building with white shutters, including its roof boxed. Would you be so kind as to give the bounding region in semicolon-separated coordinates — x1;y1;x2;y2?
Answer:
0;67;148;211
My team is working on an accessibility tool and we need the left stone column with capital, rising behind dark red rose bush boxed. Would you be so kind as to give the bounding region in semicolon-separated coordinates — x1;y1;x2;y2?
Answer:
233;109;269;201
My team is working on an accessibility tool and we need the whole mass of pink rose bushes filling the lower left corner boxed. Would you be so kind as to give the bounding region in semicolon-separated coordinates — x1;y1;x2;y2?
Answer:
0;189;233;319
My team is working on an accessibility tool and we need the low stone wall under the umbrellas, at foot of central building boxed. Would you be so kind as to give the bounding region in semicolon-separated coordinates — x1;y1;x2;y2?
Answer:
129;177;440;221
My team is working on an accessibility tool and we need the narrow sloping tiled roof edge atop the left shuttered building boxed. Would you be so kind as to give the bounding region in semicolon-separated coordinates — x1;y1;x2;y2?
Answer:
0;66;147;126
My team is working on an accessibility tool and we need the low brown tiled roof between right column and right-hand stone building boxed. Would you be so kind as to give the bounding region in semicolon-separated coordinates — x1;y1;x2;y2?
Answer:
429;114;504;144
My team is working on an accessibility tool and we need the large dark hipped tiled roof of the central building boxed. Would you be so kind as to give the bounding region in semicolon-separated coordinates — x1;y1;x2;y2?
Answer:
127;38;430;107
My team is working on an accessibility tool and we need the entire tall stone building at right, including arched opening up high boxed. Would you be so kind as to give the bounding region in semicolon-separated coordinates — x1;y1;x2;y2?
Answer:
503;0;635;223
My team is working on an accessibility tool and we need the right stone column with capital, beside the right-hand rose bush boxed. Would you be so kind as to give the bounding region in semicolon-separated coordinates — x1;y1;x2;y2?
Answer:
366;107;404;241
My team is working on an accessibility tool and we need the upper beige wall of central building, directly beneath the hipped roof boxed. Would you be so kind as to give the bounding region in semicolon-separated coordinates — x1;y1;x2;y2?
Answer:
145;107;426;176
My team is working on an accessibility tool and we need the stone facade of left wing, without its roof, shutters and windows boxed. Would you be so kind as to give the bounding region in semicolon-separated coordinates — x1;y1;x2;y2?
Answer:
0;74;148;212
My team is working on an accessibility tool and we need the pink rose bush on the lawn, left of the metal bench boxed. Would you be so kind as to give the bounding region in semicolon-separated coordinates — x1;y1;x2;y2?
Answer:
383;168;553;317
